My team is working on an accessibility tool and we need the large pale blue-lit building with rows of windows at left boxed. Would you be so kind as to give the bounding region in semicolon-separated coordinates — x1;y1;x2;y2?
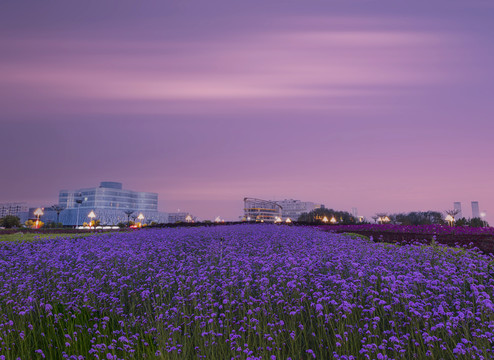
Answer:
58;181;168;225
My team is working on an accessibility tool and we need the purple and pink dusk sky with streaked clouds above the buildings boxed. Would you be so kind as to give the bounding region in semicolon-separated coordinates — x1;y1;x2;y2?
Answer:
0;0;494;224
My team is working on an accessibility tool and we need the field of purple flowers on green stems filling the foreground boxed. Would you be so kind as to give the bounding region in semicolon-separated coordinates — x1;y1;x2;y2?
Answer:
0;225;494;360
